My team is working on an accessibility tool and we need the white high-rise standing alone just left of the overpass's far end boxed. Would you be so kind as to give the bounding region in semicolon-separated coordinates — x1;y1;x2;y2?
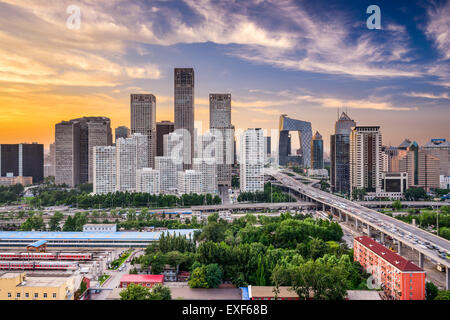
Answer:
240;128;264;192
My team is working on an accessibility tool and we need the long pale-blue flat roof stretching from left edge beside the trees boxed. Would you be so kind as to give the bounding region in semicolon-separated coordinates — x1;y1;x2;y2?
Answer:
0;229;195;243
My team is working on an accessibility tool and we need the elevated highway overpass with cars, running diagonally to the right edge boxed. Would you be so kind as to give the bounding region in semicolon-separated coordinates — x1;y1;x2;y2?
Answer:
265;168;450;290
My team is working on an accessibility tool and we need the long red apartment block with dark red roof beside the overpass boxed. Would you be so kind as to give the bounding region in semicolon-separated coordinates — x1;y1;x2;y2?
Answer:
353;236;425;300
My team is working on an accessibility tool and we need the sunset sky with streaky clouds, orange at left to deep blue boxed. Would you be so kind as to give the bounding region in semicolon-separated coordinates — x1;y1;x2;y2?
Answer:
0;0;450;155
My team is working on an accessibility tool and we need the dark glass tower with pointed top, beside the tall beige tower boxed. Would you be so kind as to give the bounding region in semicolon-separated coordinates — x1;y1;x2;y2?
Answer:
330;112;356;194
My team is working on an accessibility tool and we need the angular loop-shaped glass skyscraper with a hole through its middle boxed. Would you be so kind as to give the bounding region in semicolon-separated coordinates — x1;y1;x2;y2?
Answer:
278;114;312;168
